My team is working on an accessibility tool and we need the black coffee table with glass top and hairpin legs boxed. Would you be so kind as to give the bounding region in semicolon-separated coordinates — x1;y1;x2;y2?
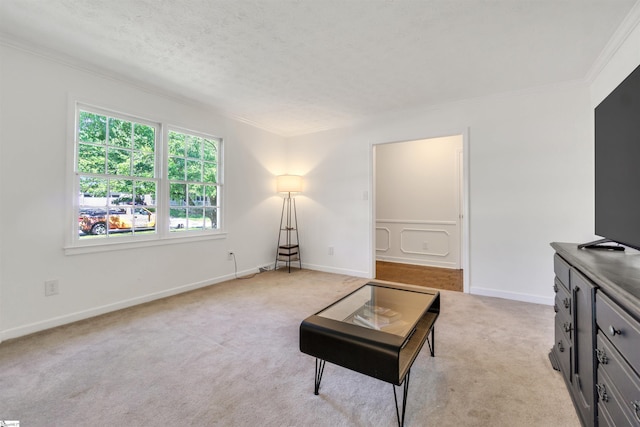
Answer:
300;282;440;426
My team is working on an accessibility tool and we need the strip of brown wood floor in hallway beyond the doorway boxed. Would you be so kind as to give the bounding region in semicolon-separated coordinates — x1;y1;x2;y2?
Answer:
376;261;463;292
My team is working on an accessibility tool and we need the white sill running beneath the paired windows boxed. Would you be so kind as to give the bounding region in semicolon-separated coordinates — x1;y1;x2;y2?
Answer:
64;232;227;255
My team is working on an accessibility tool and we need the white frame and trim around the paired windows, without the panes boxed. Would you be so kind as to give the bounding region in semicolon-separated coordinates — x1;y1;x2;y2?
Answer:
64;99;226;255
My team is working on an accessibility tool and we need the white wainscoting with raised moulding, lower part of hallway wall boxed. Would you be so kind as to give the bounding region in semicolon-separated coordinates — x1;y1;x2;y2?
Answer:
376;219;461;269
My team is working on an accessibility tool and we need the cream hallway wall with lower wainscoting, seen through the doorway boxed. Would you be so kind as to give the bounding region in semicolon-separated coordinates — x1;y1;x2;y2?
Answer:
374;135;463;269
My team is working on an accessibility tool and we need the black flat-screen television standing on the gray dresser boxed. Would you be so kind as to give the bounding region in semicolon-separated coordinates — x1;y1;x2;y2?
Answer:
580;66;640;250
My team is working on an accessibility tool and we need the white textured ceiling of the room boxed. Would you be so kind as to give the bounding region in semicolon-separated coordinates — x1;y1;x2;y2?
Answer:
0;0;637;136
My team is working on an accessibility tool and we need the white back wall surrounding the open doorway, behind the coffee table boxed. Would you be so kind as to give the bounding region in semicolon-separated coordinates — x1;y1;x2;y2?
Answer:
289;84;593;304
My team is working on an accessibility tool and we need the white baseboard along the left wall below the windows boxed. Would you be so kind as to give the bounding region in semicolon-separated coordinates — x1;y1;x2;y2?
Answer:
0;269;242;343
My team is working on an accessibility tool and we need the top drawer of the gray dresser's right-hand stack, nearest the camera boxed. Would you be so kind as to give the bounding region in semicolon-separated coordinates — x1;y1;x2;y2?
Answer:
596;292;640;370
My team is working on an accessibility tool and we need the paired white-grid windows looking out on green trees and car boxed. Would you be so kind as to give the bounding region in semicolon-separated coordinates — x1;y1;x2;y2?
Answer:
74;105;222;243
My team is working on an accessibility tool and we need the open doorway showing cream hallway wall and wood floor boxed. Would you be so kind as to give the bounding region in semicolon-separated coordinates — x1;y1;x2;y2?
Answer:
372;132;468;292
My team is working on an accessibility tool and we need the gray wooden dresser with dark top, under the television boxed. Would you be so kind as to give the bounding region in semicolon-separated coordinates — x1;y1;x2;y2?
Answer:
549;243;640;426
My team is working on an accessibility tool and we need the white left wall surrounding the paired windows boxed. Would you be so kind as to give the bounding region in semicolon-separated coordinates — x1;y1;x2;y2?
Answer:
0;46;286;341
